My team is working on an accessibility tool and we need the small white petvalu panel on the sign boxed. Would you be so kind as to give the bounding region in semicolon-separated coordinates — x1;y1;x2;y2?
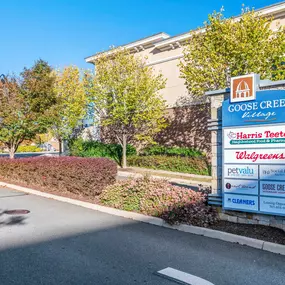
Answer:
224;164;258;179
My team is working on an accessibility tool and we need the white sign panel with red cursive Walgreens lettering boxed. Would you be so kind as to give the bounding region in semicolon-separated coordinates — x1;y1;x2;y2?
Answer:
224;149;285;164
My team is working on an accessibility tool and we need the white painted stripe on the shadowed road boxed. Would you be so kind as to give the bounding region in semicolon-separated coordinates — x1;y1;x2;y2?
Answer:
157;267;214;285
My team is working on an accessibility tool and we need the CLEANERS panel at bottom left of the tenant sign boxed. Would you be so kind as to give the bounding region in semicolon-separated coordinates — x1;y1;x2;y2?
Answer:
224;193;258;211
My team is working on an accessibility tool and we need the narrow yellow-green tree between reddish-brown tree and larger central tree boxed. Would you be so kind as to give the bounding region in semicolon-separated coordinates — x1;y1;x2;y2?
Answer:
51;66;88;153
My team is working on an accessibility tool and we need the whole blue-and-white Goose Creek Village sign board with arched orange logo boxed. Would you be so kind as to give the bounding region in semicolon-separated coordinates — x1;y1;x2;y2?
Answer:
222;74;285;215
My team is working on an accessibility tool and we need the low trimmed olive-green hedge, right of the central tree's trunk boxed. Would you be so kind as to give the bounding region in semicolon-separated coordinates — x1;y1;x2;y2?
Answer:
128;155;210;175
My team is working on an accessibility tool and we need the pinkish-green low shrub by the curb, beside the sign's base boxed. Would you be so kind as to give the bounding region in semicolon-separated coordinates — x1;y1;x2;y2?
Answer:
100;177;218;227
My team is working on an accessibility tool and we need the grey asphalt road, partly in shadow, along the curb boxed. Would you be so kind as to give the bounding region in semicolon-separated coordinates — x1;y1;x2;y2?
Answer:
0;189;285;285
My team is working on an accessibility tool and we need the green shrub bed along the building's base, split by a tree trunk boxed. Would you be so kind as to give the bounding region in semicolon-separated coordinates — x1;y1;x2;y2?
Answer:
70;139;211;175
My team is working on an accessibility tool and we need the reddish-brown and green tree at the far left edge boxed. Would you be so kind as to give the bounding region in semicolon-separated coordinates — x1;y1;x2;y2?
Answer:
0;60;56;158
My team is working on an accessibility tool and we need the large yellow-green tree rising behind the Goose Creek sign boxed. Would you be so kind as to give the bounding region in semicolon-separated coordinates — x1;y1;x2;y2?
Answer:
180;8;285;96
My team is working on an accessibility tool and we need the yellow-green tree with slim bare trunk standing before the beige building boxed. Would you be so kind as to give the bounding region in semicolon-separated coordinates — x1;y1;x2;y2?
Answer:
90;48;166;167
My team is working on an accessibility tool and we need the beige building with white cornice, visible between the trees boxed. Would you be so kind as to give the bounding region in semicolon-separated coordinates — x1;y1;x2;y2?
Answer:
85;2;285;151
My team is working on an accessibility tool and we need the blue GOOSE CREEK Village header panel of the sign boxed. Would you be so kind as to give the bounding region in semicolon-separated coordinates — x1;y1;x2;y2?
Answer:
222;90;285;127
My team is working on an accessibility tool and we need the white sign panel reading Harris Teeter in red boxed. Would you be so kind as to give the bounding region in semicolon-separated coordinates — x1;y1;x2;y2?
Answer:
224;125;285;149
